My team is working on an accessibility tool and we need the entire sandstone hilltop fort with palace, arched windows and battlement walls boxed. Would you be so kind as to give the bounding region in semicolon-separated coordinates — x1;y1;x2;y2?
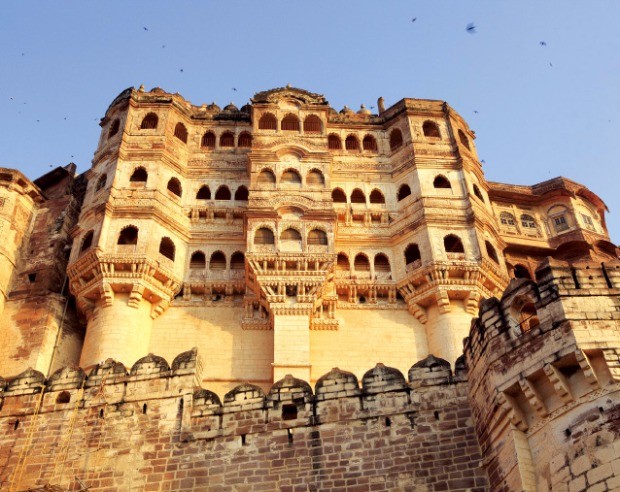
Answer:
0;86;620;492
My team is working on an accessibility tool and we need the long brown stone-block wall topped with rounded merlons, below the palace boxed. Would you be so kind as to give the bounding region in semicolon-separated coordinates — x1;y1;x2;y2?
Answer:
0;349;488;492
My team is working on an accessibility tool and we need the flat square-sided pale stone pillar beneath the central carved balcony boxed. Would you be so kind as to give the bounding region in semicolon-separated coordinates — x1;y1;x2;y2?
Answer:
272;314;310;381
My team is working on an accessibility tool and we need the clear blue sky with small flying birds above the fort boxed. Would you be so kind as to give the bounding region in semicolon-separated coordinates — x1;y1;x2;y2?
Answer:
0;0;620;243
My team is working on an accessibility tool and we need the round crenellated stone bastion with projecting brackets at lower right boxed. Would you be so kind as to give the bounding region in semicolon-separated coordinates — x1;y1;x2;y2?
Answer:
464;259;620;490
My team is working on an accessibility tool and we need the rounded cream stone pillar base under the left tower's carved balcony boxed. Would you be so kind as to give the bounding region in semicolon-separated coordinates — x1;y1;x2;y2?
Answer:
80;293;153;370
